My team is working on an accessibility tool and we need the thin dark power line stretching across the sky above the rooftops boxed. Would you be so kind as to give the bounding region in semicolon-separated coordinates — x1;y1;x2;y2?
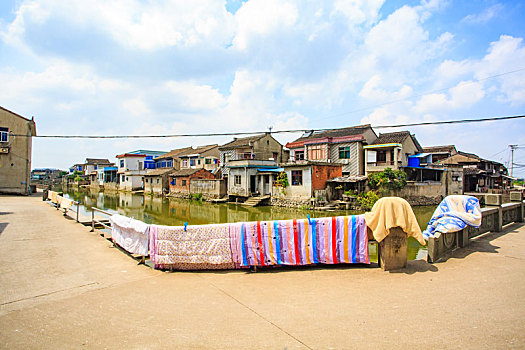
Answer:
15;115;525;139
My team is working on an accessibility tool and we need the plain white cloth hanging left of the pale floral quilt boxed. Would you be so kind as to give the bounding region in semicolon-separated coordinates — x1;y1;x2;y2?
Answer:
109;214;149;256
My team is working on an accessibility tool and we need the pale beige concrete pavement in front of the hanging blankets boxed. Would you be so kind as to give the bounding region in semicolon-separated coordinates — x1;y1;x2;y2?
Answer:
0;196;525;349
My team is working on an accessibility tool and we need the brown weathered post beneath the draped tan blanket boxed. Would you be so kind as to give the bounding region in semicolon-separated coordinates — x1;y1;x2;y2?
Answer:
378;227;407;271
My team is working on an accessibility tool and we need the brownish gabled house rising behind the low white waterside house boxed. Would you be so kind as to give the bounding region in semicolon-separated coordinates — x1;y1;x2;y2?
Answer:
219;132;289;176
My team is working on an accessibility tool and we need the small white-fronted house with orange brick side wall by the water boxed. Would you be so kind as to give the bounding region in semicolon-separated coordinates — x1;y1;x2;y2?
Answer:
272;161;342;206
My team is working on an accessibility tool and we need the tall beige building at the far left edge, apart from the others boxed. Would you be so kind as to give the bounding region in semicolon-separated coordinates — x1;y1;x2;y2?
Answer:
0;107;36;195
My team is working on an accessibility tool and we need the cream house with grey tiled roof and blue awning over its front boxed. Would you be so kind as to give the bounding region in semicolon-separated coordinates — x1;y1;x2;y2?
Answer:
363;131;423;175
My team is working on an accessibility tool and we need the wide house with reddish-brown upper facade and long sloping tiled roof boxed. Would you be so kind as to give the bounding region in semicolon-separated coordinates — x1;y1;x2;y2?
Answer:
286;125;377;175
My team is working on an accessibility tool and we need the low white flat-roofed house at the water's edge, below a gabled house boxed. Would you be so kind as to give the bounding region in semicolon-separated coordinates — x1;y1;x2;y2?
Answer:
226;159;284;200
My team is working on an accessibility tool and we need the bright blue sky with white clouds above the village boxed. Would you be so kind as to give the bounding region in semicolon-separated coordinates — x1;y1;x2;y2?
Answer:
0;0;525;176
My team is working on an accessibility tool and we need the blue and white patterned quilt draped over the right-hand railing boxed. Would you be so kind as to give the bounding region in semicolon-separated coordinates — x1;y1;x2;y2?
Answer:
423;195;481;239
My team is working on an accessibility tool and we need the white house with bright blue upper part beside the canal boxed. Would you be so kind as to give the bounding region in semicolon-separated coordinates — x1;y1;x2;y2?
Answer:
116;150;166;191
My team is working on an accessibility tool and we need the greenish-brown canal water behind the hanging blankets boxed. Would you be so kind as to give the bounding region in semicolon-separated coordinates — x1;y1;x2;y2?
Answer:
64;190;435;261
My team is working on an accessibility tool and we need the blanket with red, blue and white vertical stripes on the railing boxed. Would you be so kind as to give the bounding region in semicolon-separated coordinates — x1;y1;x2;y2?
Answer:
230;215;370;267
